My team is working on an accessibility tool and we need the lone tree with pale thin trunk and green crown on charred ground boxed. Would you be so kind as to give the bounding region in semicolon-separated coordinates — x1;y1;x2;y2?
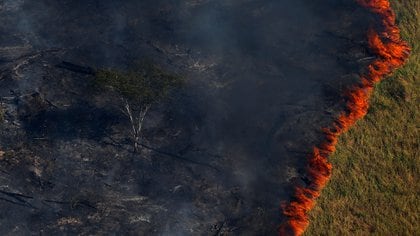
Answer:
95;62;183;151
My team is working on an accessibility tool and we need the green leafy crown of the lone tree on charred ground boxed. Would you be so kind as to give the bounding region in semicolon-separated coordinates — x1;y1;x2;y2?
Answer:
95;61;183;105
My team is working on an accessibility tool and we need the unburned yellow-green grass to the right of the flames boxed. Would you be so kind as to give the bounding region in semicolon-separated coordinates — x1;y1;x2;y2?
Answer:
306;0;420;235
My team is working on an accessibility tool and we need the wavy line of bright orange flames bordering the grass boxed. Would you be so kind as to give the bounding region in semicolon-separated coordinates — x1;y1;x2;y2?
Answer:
279;0;410;235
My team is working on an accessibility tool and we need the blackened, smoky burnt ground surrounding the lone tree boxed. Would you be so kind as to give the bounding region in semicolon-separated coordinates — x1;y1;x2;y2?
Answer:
0;0;375;235
